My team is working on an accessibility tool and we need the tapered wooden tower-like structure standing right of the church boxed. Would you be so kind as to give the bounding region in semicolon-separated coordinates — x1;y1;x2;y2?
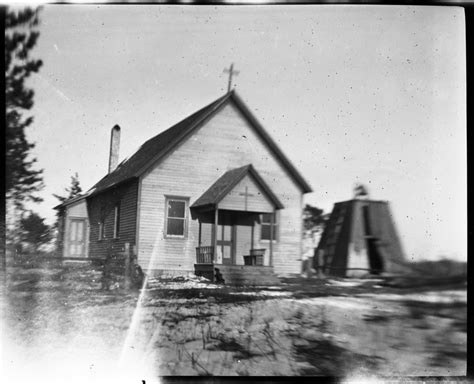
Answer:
313;193;407;277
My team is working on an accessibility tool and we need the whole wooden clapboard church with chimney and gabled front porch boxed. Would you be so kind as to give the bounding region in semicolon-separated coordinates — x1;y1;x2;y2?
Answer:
56;90;311;278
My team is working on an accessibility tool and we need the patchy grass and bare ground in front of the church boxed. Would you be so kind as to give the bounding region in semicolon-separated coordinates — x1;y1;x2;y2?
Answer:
1;261;467;383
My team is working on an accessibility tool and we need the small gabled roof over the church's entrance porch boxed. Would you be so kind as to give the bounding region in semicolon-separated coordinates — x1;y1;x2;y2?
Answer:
191;164;283;209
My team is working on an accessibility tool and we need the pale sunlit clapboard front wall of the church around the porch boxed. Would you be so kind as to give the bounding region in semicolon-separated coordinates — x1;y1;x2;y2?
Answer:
138;104;302;273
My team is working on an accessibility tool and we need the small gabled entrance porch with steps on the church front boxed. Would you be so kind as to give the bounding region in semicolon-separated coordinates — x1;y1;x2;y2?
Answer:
191;165;283;284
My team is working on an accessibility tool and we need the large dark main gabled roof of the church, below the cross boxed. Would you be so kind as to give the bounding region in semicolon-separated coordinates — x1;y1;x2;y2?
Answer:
90;90;312;195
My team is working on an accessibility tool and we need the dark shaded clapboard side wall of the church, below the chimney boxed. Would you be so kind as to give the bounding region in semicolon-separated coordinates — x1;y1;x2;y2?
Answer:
88;180;138;258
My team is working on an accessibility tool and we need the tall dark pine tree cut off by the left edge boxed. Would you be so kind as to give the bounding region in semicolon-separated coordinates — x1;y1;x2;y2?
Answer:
5;8;43;209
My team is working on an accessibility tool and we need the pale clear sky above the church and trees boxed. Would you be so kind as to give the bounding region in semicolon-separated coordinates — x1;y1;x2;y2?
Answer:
19;5;467;260
